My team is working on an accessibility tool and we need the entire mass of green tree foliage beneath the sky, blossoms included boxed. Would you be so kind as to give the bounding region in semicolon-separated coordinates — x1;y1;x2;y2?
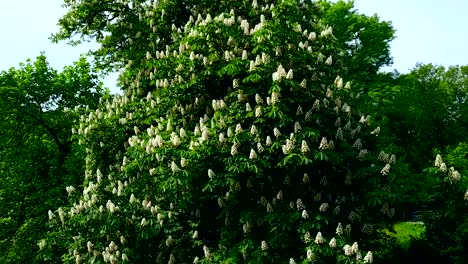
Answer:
0;0;468;263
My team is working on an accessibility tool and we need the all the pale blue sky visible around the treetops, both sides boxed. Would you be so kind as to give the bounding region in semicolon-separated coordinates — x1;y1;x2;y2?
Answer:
0;0;468;92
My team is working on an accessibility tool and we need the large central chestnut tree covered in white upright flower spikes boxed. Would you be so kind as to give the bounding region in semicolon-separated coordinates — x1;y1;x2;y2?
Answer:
43;0;396;263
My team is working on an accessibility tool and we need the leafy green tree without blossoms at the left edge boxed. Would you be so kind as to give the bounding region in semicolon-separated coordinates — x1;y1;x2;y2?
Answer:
0;54;102;263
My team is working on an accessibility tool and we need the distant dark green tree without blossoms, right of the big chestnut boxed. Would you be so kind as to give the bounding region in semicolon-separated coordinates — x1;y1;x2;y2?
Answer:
367;64;468;216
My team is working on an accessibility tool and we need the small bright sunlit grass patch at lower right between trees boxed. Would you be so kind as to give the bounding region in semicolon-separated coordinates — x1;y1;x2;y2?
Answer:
385;222;426;250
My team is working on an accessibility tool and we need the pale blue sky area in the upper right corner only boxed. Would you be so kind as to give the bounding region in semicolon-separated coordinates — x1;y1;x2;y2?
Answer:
355;0;468;73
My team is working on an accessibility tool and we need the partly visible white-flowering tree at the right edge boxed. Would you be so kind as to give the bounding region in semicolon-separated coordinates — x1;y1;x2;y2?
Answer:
423;154;468;263
